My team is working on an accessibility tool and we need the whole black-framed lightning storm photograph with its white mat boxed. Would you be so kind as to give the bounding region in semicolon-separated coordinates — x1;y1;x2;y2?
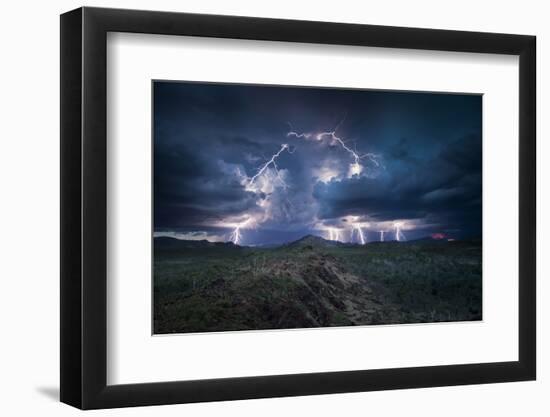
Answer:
61;8;536;409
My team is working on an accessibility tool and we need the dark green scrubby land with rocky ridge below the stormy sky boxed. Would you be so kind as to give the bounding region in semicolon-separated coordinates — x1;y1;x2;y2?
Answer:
154;236;482;334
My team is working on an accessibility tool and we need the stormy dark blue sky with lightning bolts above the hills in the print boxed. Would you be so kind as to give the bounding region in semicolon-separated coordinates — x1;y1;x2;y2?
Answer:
153;81;482;245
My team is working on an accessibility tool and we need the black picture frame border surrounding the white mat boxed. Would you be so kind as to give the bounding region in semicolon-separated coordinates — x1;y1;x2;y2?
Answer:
60;7;536;409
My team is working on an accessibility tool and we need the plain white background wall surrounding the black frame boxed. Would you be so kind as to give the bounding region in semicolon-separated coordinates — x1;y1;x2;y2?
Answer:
0;0;550;417
